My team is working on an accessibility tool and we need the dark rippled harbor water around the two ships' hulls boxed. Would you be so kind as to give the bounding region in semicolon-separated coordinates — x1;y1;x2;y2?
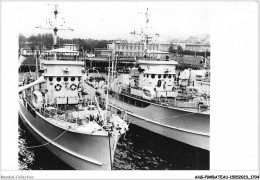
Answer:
18;116;210;170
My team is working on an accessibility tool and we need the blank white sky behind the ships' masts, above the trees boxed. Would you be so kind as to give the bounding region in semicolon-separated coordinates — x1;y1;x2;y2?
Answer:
8;1;210;41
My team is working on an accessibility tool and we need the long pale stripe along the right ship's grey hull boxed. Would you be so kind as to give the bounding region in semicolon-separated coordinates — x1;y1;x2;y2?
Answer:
109;103;209;137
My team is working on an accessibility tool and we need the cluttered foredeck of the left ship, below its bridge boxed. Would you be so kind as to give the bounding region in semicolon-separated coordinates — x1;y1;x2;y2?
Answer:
20;93;107;134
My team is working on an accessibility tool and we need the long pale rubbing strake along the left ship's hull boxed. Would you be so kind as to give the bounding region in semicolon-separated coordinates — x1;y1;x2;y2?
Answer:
19;108;103;166
